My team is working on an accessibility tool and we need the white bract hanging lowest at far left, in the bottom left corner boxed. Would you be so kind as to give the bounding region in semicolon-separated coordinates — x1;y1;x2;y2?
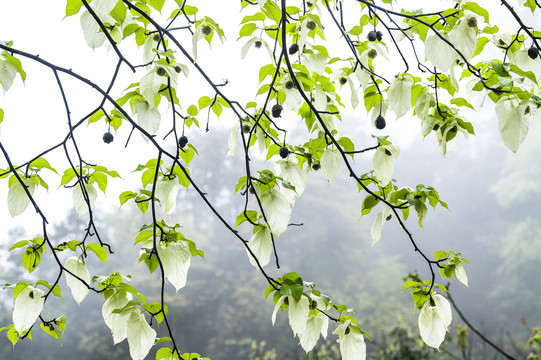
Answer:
13;286;45;335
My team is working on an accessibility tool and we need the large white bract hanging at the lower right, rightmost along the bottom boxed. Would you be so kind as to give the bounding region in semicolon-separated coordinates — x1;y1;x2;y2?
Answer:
418;294;452;349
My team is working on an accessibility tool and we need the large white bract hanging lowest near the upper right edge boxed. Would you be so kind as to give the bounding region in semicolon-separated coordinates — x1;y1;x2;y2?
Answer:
496;96;530;152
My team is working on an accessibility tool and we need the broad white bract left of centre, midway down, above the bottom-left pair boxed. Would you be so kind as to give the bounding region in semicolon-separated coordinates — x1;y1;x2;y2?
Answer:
157;241;191;291
